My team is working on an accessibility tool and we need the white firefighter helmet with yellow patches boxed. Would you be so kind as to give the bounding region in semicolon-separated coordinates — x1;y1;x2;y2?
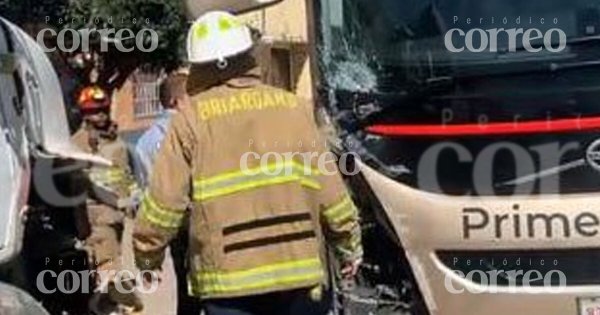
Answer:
187;11;253;68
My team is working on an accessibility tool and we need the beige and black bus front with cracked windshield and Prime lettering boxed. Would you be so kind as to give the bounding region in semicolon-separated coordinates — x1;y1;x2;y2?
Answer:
309;0;600;315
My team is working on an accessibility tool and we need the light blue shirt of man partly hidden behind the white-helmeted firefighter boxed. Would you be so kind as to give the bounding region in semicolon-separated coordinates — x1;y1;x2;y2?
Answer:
134;110;175;187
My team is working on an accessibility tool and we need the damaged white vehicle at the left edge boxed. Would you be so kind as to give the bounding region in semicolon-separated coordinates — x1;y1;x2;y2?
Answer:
0;17;110;315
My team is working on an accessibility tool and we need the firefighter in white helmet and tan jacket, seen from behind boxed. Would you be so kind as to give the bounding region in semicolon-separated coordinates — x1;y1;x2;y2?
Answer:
133;12;362;315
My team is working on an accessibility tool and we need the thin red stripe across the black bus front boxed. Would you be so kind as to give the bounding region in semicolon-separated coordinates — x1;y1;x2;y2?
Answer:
366;117;600;136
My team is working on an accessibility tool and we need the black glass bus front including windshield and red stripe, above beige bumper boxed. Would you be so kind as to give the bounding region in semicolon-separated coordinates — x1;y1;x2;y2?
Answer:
314;0;600;195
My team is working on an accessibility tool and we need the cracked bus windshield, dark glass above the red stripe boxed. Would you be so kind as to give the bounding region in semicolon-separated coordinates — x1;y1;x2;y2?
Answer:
317;0;600;123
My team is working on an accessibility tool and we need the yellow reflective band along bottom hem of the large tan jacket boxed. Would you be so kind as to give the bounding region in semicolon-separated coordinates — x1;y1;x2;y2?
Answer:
190;258;324;296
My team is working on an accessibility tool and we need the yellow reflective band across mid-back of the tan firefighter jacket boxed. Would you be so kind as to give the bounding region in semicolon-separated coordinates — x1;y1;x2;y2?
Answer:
194;162;321;201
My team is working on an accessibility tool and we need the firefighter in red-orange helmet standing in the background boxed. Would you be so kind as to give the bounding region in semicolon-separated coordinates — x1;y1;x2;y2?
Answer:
72;85;142;315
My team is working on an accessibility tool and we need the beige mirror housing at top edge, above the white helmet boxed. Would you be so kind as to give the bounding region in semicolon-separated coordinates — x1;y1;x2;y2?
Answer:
185;0;283;20
